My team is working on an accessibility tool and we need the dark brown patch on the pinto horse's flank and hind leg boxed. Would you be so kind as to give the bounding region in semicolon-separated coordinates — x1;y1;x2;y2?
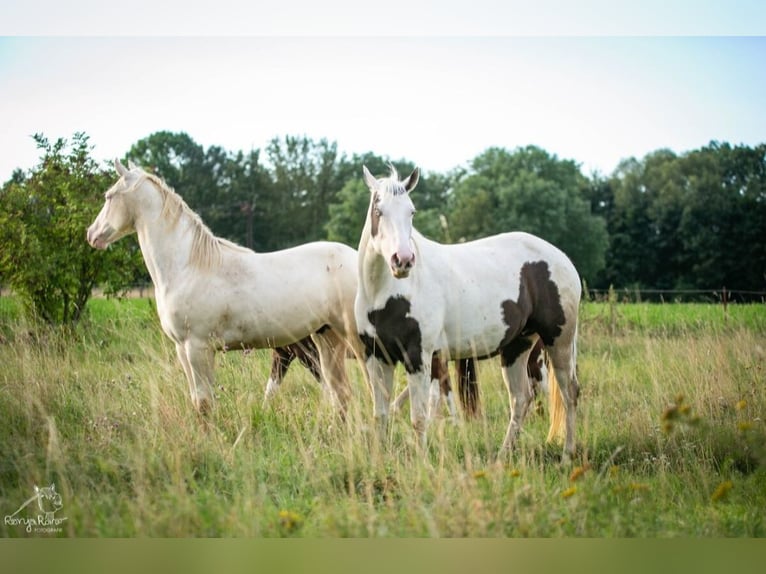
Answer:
498;261;566;366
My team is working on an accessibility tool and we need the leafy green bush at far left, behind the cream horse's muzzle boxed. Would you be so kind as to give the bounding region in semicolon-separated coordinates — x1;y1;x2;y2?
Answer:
0;133;141;324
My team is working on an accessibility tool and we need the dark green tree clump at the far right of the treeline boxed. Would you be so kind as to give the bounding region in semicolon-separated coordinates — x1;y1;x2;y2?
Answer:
594;142;766;290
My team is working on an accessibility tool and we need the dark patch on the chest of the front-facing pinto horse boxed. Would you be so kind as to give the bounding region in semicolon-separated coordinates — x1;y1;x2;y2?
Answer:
360;295;423;374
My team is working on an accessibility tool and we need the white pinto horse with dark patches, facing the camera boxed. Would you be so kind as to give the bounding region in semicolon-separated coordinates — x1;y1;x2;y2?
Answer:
355;166;581;460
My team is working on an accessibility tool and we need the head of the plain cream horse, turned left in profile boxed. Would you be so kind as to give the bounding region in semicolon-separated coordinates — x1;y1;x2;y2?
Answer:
87;160;153;249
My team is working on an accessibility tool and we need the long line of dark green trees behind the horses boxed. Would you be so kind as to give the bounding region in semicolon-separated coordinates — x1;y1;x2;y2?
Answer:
2;132;766;302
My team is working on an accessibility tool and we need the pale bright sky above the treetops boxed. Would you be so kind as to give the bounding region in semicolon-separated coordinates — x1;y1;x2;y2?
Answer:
0;0;766;182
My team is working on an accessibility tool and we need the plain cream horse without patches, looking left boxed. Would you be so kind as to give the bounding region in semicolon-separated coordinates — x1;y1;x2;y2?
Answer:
87;161;359;414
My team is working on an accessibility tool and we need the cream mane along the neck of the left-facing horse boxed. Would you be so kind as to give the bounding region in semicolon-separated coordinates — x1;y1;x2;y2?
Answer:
145;172;247;270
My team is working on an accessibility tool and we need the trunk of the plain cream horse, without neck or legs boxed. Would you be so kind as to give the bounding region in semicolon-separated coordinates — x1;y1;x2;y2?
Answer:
161;242;356;348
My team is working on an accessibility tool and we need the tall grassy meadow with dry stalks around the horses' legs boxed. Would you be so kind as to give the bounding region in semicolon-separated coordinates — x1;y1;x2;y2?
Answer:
0;297;766;537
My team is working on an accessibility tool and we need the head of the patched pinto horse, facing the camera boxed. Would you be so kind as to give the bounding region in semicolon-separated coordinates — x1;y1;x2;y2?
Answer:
362;166;420;279
